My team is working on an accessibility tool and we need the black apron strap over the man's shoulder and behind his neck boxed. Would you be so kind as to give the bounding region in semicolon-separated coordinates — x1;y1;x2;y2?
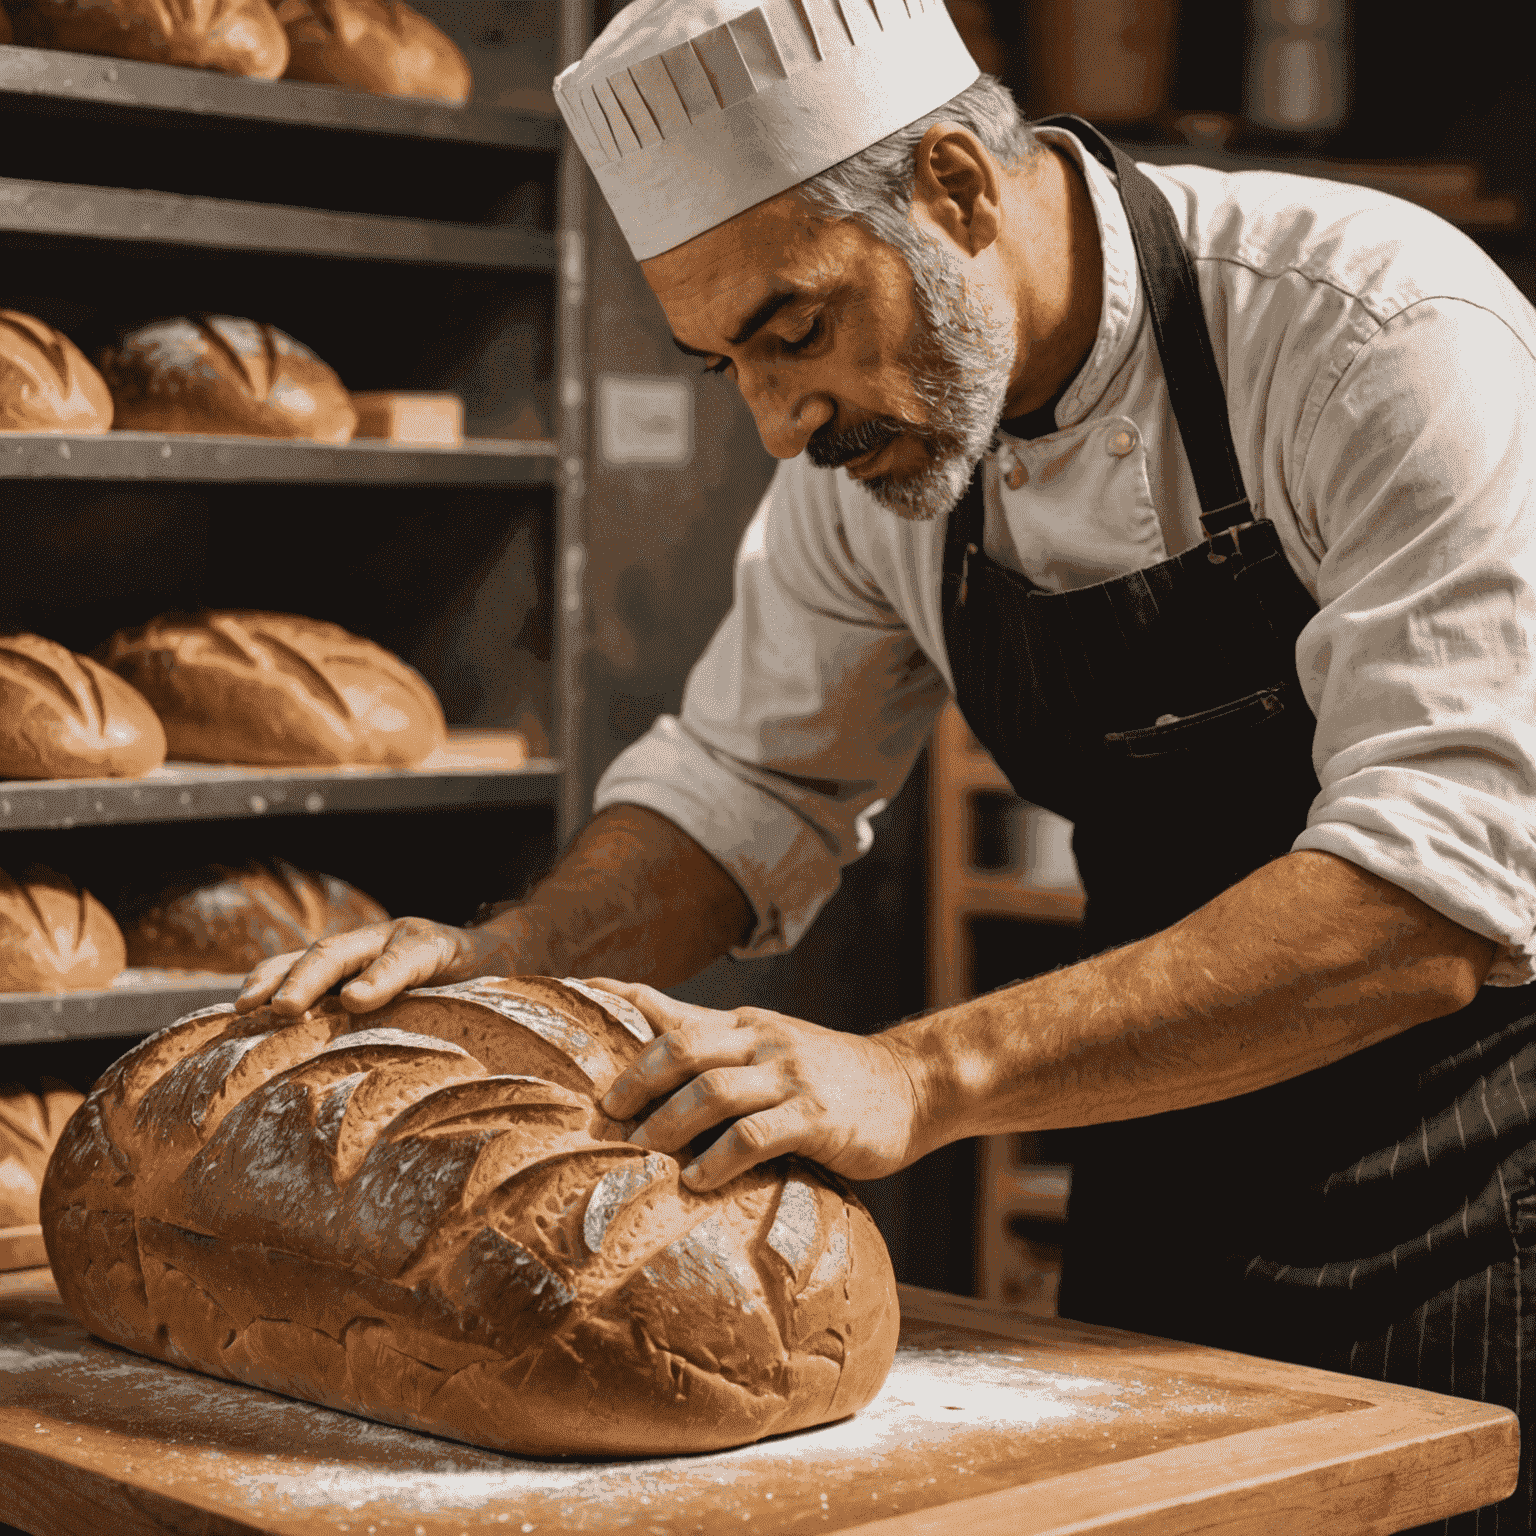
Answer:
1037;112;1253;538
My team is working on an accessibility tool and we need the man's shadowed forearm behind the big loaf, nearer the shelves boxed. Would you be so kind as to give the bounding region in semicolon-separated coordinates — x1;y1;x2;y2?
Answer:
475;805;753;988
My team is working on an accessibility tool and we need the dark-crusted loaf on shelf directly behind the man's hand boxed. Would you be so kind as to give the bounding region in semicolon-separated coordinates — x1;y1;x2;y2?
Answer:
123;859;389;972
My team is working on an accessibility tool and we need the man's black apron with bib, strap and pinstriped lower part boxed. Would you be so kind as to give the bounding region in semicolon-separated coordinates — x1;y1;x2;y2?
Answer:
943;118;1536;1536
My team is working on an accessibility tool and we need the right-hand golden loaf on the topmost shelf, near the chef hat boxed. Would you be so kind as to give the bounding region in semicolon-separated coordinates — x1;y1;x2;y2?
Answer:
276;0;475;103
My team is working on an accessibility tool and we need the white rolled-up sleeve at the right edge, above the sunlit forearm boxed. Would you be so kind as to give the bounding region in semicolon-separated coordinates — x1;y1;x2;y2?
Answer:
1293;300;1536;986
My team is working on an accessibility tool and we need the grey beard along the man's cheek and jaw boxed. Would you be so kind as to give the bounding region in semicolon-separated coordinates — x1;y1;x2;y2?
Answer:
835;235;1015;522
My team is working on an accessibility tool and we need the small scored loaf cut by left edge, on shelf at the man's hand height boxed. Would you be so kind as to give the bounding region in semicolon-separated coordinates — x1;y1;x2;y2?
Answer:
0;865;126;992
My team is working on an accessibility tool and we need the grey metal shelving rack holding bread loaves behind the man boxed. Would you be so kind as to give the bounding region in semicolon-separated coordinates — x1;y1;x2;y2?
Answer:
0;18;590;1056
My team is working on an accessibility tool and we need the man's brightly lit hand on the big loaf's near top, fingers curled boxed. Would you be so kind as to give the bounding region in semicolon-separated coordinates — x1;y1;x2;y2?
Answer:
590;980;926;1190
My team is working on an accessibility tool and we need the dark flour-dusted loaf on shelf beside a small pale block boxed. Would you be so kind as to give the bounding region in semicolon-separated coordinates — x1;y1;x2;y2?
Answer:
100;315;358;442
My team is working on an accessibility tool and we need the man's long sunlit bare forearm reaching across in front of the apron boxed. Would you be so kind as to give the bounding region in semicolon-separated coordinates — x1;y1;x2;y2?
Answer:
882;852;1495;1152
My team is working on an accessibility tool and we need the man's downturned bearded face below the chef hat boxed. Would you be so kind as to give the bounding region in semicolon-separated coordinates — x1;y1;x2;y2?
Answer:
644;194;1014;518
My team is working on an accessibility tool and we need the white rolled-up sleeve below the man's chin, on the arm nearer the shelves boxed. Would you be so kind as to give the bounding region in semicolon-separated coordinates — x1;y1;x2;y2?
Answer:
596;459;948;958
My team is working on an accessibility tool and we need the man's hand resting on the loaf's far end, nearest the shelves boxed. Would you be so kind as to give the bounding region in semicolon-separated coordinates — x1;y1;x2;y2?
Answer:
235;917;505;1015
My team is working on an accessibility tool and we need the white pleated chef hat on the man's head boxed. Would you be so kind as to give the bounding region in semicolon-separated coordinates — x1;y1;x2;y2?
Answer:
554;0;980;261
